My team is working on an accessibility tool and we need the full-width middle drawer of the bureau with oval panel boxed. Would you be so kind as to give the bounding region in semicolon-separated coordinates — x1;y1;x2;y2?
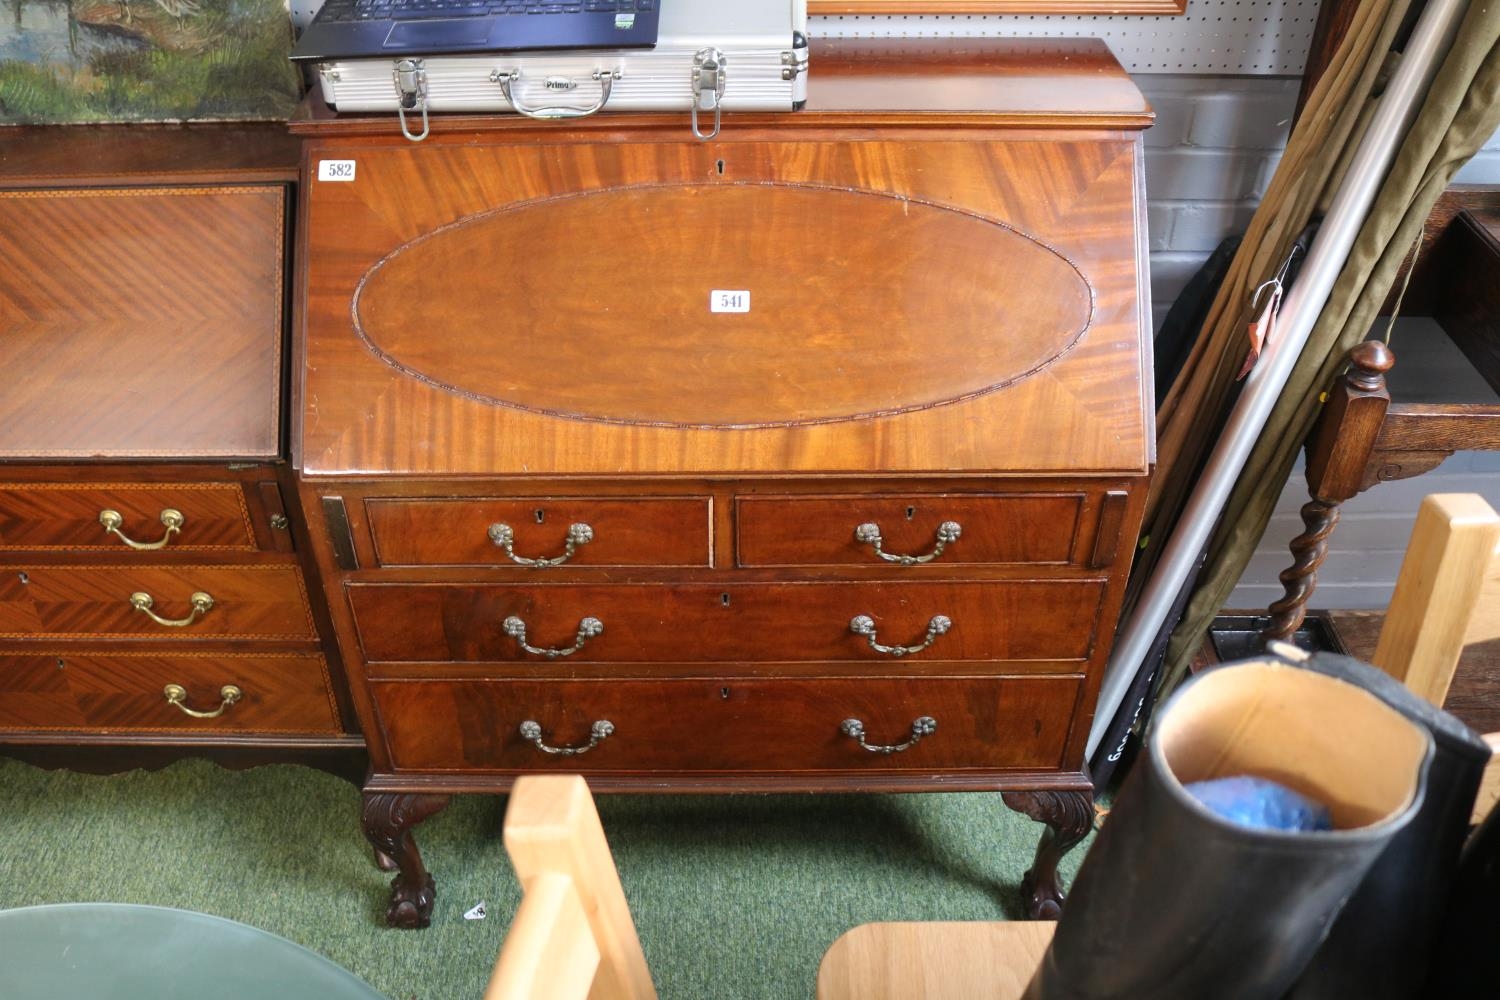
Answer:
348;579;1104;663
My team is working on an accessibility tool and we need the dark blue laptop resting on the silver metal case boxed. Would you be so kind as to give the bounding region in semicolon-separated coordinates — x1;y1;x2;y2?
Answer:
291;0;660;63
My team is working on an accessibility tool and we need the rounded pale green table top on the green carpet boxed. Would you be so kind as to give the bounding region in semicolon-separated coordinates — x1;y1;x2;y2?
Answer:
0;903;384;1000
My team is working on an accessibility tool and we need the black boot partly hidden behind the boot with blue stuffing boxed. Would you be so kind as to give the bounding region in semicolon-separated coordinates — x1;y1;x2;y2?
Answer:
1274;643;1490;1000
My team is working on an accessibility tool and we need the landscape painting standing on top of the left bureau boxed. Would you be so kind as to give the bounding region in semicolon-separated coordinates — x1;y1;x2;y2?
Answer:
0;0;300;124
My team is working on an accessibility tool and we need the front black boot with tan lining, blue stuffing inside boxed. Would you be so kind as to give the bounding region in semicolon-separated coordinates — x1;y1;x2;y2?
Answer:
1026;658;1433;1000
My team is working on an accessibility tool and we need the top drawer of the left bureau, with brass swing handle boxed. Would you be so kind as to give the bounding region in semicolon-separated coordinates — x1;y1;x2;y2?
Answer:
0;483;257;558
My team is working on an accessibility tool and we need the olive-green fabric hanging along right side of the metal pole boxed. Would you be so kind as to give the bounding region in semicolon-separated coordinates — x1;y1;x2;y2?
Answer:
1161;0;1500;690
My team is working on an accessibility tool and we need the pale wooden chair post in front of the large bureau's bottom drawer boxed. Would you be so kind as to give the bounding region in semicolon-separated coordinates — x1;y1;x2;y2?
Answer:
485;775;657;1000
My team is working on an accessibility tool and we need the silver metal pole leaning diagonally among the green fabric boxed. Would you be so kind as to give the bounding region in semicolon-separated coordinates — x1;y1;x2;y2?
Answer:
1086;0;1467;757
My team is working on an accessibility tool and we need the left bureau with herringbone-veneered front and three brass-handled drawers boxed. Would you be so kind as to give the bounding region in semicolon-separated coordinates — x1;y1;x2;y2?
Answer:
0;126;362;774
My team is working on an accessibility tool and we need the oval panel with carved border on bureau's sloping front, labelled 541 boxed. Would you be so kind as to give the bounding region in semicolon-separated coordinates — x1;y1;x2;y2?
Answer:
354;184;1094;427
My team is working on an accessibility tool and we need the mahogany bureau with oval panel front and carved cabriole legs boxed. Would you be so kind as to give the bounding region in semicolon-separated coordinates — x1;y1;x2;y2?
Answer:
293;42;1154;927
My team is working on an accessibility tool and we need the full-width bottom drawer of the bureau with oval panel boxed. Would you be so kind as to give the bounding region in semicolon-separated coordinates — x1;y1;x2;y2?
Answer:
371;675;1082;772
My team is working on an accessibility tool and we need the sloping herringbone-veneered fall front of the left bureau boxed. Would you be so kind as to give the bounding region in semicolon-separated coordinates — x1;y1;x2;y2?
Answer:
0;184;287;459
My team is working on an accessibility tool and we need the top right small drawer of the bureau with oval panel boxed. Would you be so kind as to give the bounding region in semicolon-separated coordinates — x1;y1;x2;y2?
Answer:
735;493;1085;567
